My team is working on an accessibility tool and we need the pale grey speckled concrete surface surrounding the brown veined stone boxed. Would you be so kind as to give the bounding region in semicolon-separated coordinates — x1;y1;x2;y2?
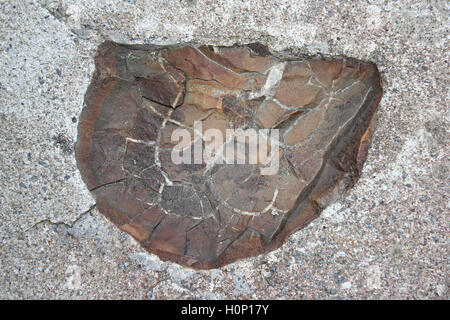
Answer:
0;0;450;299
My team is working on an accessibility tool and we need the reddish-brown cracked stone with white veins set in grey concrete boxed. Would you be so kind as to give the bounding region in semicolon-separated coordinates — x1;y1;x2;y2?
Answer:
76;42;382;269
